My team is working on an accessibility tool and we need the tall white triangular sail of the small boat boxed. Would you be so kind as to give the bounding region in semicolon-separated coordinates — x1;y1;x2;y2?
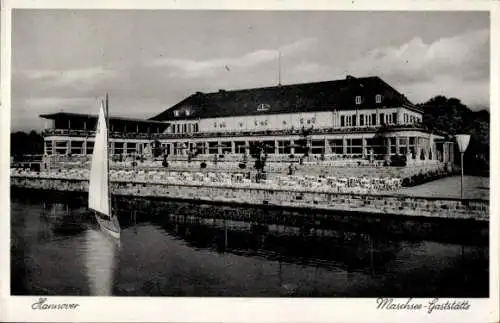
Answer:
89;102;110;216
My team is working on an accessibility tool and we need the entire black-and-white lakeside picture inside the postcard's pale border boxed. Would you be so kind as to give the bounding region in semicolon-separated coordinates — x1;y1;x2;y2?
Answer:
0;1;498;322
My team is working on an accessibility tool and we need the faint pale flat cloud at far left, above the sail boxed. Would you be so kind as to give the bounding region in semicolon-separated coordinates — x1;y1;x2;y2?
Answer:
23;66;116;87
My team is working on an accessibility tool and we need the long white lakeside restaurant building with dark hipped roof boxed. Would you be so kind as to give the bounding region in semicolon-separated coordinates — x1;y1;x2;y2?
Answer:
41;76;453;162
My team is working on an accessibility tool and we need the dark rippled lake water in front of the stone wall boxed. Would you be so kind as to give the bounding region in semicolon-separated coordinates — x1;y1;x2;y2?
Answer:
11;194;489;297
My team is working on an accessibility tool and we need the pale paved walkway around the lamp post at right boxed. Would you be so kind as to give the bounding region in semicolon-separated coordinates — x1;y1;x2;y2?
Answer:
393;176;490;200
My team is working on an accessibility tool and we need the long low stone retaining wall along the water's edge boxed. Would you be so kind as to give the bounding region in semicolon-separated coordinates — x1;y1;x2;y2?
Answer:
11;176;489;221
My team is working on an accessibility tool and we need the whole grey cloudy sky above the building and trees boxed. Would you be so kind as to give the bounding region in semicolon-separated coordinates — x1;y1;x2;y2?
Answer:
11;10;489;130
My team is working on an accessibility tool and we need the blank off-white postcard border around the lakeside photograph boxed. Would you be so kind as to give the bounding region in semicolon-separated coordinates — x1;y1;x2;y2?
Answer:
0;0;500;322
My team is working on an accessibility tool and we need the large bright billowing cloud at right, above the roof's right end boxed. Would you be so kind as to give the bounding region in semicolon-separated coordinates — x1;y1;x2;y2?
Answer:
345;29;489;106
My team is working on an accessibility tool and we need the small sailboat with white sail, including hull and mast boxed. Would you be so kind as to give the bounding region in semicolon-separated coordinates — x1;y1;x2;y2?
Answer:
89;94;120;239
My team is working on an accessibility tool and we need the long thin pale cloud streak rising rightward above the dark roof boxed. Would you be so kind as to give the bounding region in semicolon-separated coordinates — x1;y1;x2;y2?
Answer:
150;38;316;78
